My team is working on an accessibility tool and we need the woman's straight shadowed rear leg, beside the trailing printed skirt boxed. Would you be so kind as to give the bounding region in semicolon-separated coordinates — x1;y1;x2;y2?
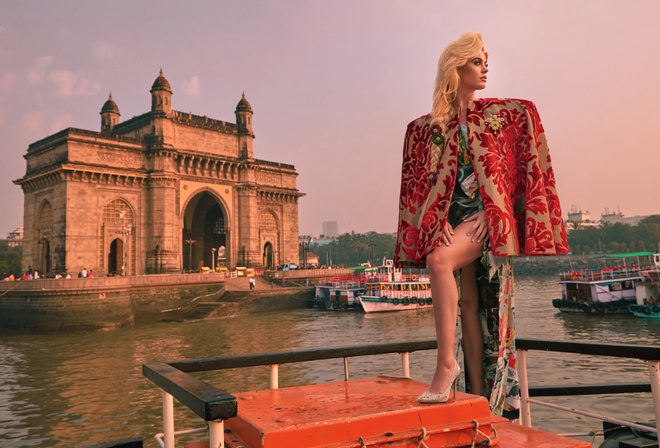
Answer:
461;261;484;395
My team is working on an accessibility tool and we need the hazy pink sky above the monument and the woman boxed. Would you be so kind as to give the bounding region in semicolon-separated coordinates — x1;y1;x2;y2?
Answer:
0;0;660;238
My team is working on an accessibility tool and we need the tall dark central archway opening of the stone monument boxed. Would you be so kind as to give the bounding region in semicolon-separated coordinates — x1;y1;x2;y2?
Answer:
181;192;229;272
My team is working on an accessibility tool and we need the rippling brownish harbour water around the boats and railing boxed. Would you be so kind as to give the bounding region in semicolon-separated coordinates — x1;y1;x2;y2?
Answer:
0;277;660;448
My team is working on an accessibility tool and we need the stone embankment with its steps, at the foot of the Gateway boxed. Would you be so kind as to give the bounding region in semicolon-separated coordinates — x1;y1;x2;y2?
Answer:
0;274;314;332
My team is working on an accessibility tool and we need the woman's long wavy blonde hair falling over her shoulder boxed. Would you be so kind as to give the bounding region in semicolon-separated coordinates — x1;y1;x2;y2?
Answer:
431;32;486;130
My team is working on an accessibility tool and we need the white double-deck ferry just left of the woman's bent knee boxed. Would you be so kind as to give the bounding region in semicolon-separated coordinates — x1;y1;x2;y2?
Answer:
360;260;433;313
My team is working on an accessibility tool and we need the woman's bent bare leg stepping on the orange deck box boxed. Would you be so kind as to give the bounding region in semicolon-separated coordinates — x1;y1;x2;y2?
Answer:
426;222;483;393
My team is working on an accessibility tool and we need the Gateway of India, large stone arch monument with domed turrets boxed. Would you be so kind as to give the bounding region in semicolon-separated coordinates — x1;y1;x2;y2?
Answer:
14;70;304;276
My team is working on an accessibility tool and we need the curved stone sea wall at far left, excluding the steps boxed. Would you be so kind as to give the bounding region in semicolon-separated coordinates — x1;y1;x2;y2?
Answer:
0;274;224;332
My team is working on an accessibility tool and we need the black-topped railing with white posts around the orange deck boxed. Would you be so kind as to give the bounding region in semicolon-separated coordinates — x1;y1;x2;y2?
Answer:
142;339;660;448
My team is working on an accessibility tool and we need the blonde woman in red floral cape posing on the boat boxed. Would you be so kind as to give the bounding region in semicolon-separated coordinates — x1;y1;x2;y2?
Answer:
395;33;568;414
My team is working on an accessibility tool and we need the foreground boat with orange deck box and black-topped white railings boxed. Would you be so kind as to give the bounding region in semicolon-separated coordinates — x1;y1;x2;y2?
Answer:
137;339;660;448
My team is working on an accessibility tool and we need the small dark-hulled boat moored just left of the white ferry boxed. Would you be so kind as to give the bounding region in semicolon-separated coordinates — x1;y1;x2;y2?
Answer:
314;276;365;311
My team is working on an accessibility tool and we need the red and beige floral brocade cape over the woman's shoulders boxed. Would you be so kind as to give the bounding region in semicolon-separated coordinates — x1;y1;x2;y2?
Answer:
394;98;569;268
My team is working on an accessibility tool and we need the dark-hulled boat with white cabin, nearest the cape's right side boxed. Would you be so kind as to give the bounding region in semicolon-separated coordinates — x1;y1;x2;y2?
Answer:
552;252;654;314
